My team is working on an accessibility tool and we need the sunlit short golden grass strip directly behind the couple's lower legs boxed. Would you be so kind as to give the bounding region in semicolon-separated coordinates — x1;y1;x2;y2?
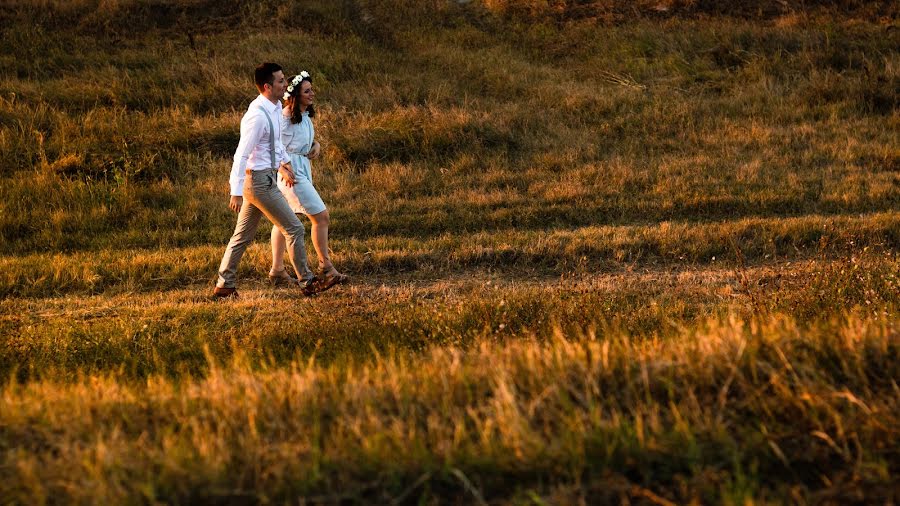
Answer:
0;212;900;297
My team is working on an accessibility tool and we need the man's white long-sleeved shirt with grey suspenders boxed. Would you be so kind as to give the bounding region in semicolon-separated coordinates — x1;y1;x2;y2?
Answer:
229;95;290;197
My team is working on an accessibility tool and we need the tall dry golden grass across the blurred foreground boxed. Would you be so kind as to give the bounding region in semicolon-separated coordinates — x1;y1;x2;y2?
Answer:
0;316;900;504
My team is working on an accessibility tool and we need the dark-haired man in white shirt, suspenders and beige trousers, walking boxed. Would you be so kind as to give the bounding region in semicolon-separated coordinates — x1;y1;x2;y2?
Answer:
213;63;316;298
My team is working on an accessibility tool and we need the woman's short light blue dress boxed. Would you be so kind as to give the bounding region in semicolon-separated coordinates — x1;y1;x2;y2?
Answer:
278;109;325;215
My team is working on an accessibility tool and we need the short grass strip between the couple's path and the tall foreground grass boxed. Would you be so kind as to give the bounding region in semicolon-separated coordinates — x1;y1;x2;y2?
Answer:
0;255;900;381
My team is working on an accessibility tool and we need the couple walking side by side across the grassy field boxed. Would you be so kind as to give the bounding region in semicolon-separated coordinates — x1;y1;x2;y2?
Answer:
213;63;348;298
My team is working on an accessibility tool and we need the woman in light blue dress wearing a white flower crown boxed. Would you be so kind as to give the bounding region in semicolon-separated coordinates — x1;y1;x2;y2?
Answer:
269;71;349;291
